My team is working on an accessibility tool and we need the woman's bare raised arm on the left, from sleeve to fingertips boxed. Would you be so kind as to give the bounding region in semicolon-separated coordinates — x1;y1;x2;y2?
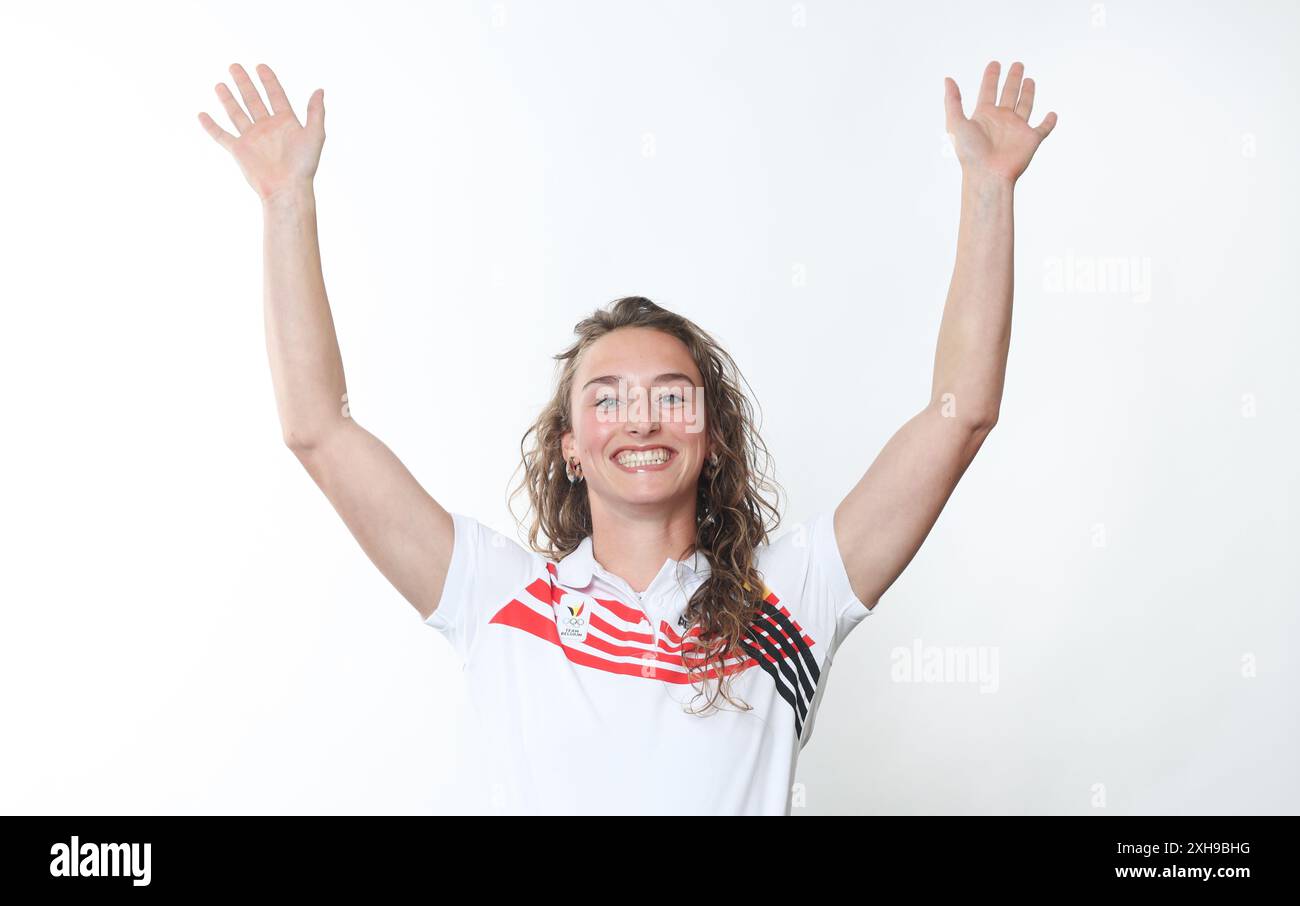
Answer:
199;64;454;619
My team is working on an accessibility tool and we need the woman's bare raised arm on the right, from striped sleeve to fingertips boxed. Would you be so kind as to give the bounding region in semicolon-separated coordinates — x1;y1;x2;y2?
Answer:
835;61;1057;607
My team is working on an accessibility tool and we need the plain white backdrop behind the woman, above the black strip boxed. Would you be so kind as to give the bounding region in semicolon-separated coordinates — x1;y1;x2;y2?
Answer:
0;0;1300;814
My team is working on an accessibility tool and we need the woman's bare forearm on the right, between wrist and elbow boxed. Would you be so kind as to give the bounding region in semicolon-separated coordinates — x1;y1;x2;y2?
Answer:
931;173;1014;426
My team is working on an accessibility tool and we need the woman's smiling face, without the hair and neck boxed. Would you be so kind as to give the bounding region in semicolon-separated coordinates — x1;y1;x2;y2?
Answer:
563;328;710;507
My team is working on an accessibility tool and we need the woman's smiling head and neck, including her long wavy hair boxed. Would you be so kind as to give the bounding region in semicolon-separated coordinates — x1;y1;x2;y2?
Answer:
512;296;780;702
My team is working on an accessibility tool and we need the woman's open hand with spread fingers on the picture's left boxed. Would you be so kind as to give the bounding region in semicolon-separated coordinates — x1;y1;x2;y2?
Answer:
199;62;325;201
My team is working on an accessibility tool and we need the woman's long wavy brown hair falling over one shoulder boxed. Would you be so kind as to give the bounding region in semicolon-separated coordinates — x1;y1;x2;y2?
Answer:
510;296;783;710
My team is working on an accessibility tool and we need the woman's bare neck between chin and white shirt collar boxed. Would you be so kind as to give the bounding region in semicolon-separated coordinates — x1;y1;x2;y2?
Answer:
592;497;696;594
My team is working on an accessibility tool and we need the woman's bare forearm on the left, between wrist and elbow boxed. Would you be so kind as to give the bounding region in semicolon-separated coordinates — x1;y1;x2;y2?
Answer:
263;182;347;448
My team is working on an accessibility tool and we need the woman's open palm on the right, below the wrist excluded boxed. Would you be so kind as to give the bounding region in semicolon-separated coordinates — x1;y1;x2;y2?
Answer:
944;60;1057;182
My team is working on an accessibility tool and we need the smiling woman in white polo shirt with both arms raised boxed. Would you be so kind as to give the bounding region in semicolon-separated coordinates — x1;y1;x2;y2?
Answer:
199;62;1057;814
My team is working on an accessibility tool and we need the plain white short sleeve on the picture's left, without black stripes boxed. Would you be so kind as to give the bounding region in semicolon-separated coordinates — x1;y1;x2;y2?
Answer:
425;512;546;666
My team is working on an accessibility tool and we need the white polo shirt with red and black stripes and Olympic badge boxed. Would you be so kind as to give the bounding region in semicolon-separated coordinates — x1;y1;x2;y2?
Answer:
426;511;872;815
